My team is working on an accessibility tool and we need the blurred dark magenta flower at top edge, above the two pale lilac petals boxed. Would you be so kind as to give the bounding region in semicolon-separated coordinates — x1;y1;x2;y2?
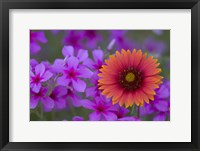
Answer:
63;30;83;49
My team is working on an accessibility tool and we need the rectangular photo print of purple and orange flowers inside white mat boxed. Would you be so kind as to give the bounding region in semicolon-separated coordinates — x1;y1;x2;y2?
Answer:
30;30;170;122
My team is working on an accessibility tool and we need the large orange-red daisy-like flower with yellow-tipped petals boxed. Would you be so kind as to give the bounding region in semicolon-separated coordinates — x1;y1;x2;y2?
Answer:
98;49;163;108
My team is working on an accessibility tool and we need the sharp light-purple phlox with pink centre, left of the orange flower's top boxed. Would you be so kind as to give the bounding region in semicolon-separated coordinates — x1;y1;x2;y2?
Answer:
57;56;93;92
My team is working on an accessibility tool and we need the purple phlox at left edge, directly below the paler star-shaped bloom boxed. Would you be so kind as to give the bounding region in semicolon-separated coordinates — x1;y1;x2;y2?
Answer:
30;87;54;109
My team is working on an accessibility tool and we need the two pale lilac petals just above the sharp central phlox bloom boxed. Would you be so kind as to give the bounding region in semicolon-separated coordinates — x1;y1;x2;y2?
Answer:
62;46;88;62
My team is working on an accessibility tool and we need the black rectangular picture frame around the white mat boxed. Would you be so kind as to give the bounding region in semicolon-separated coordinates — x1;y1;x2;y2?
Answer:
0;0;200;151
